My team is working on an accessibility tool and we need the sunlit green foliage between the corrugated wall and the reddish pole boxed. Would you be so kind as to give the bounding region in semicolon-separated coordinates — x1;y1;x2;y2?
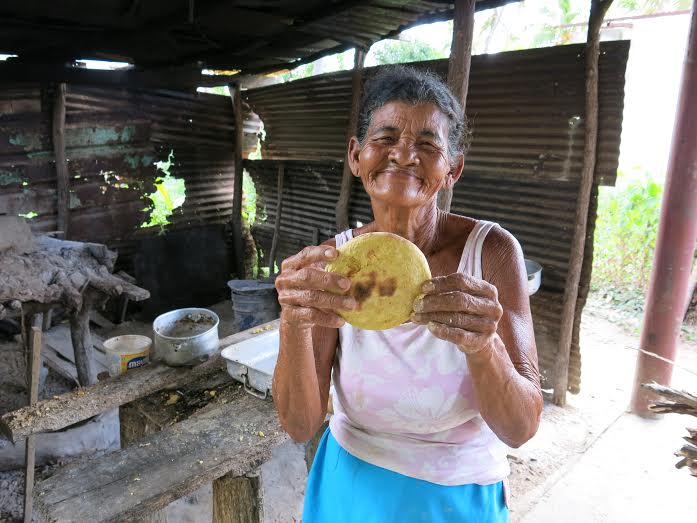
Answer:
592;171;663;308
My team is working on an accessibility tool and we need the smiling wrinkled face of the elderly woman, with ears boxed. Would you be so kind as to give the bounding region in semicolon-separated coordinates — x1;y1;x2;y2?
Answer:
349;102;463;207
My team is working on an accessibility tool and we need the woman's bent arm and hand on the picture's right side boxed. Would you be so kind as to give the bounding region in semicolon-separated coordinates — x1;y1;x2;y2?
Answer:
412;229;543;447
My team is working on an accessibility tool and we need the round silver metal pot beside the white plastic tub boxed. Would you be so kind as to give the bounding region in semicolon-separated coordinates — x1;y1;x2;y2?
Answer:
153;308;220;367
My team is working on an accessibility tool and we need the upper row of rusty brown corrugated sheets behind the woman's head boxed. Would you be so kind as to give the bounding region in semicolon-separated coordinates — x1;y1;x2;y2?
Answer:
245;42;629;185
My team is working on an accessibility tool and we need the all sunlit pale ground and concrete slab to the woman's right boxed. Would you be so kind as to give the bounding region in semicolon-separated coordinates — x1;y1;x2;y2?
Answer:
511;309;697;523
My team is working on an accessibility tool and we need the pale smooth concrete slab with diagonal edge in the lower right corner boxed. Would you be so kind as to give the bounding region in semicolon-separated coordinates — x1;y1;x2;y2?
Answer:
520;414;697;523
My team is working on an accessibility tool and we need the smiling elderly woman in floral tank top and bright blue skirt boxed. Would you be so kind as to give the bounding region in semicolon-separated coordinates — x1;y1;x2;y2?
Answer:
273;67;543;523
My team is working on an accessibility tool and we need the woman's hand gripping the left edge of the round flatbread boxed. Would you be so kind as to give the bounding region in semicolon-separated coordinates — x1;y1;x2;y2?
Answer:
276;245;357;329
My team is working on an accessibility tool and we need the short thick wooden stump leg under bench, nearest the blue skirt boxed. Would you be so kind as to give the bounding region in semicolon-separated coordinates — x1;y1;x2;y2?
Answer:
213;473;264;523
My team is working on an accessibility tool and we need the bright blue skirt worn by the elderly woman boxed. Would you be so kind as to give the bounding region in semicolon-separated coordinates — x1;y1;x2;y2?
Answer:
302;429;508;523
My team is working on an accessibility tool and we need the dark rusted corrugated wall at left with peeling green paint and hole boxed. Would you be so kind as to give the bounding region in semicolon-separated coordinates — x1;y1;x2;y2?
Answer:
0;85;259;272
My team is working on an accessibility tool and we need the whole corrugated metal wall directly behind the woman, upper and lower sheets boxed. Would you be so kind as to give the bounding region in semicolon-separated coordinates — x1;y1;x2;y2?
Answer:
246;42;629;392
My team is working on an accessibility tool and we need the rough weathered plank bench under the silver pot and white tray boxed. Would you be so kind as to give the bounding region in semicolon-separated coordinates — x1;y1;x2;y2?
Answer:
0;321;302;523
